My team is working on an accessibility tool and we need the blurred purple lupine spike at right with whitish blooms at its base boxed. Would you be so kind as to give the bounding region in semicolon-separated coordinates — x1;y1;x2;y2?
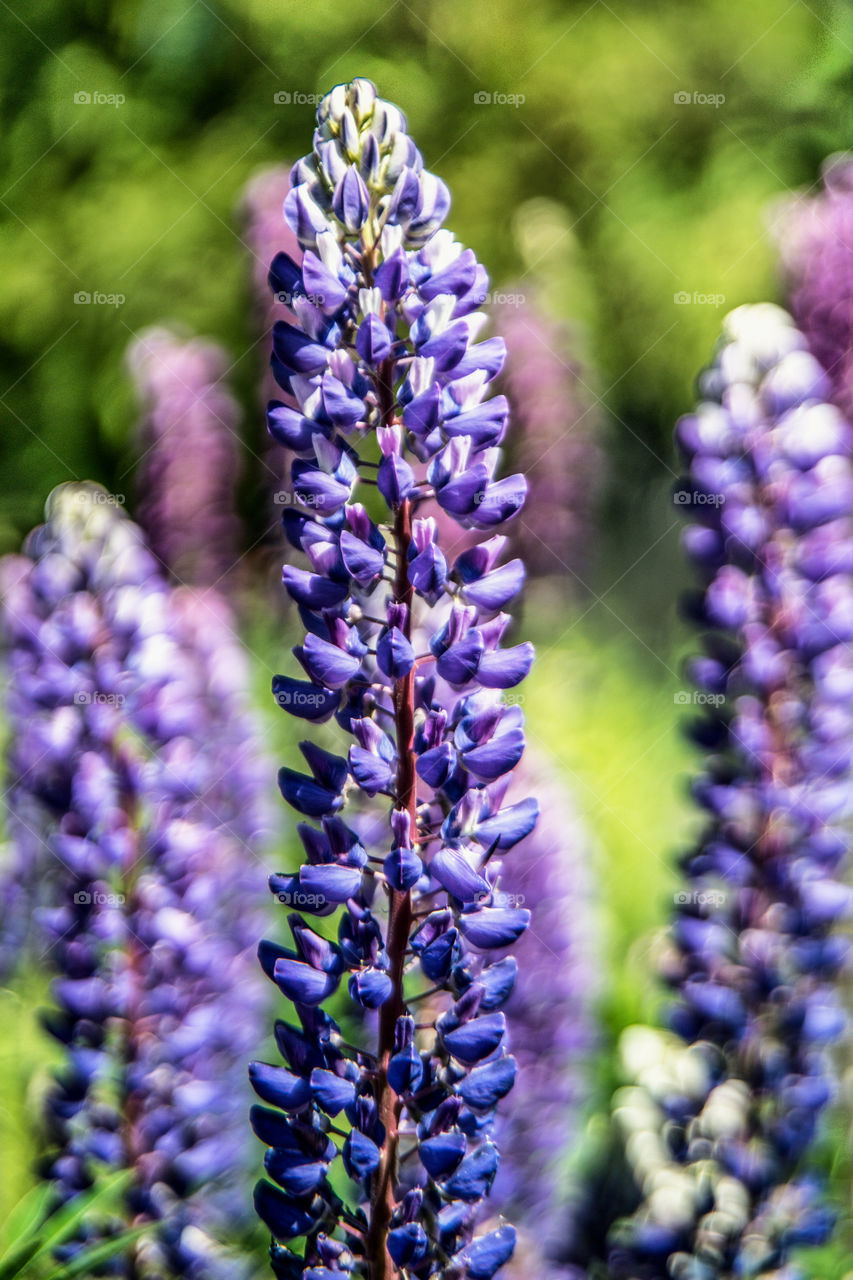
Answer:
610;306;853;1280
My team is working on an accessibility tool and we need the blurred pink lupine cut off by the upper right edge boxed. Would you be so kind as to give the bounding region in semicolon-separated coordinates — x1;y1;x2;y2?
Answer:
777;155;853;417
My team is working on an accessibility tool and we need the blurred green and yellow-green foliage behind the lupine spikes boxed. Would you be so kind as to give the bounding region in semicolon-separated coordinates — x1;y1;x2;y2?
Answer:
0;0;853;1274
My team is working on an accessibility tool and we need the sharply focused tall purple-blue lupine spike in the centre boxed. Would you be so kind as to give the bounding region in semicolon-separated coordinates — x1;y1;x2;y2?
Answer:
251;79;534;1280
